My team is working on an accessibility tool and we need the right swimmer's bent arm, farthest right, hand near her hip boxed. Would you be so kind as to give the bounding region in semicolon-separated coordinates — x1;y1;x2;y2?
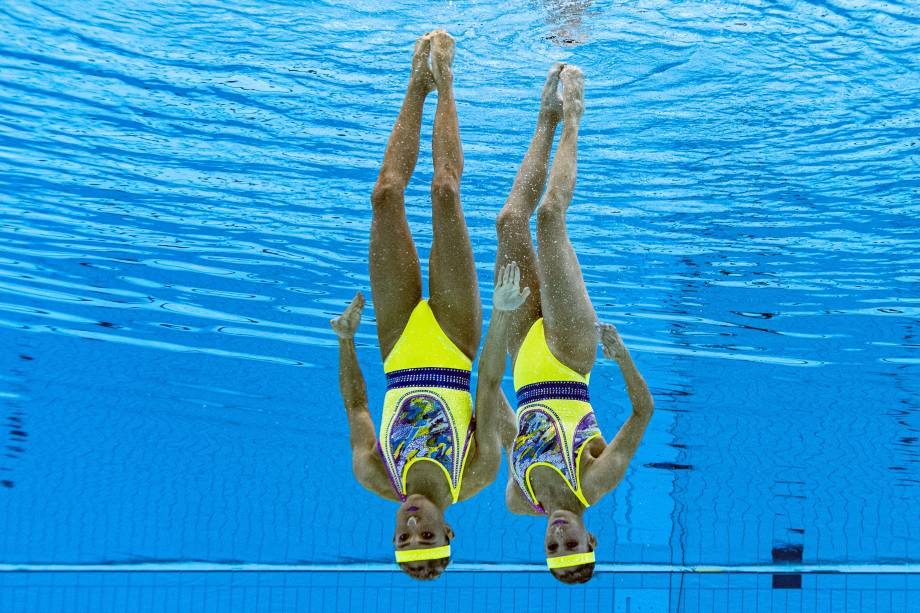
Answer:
585;324;655;502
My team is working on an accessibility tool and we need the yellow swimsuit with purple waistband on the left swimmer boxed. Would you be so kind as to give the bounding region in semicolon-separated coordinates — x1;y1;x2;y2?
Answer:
377;300;475;502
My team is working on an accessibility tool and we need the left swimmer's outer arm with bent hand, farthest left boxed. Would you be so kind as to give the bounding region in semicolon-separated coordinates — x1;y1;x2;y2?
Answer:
329;292;398;500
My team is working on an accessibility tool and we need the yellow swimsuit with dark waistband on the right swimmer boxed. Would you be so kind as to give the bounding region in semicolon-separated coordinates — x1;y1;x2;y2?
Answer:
511;317;601;512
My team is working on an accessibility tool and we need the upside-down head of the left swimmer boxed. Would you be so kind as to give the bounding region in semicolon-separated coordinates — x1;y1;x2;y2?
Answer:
393;494;454;579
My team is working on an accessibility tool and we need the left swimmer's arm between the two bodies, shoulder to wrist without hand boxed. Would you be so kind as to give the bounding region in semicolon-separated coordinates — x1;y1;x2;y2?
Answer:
460;309;511;500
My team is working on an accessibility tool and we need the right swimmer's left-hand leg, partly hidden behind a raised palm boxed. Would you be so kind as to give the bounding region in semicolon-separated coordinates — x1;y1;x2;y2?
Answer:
495;64;562;361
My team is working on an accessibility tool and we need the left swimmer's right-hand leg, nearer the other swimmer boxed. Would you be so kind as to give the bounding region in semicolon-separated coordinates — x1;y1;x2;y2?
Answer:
428;30;482;359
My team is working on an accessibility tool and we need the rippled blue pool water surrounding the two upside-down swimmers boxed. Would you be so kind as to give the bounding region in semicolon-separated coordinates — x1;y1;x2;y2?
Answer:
0;0;920;613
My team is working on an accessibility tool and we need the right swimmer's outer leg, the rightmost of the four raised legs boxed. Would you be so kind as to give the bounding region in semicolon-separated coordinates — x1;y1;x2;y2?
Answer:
537;66;597;374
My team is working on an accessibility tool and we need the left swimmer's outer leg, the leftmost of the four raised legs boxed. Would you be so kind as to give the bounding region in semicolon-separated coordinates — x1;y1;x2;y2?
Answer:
368;34;434;359
